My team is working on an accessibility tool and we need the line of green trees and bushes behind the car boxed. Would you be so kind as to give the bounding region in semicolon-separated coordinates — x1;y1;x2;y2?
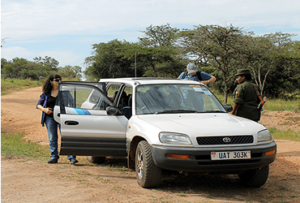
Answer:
0;24;300;100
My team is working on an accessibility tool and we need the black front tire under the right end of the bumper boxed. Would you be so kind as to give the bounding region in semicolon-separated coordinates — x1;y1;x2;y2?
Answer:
239;165;269;187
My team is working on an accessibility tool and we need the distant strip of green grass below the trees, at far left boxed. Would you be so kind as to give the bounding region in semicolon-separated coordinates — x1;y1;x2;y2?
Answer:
0;78;43;95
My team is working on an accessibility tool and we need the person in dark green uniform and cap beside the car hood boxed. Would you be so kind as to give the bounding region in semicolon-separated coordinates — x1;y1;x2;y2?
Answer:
231;69;260;122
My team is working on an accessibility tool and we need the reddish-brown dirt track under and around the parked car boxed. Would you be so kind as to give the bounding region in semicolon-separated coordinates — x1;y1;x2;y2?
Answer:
0;87;300;203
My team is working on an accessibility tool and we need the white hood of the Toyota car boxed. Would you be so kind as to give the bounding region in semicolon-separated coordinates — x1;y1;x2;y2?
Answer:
139;113;266;136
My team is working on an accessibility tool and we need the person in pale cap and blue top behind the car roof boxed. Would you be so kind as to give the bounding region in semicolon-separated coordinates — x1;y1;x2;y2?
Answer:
178;63;217;85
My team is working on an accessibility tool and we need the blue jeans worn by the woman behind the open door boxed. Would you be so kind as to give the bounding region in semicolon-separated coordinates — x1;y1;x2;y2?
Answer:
45;115;76;160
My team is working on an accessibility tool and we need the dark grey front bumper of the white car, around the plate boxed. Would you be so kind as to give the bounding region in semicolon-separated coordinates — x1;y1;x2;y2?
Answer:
151;142;277;172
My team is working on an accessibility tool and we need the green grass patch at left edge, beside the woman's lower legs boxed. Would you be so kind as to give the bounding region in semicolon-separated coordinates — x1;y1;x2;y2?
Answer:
0;132;49;159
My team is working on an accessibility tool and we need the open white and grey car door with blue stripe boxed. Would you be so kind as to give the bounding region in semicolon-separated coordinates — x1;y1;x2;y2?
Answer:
54;82;128;156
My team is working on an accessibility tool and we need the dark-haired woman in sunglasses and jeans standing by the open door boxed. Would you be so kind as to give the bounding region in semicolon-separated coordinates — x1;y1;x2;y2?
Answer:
36;74;78;164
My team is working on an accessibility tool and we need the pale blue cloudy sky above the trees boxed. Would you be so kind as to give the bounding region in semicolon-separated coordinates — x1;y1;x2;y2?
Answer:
0;0;300;70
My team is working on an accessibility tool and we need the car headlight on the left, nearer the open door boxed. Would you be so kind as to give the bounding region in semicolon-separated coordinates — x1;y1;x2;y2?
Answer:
159;132;192;145
